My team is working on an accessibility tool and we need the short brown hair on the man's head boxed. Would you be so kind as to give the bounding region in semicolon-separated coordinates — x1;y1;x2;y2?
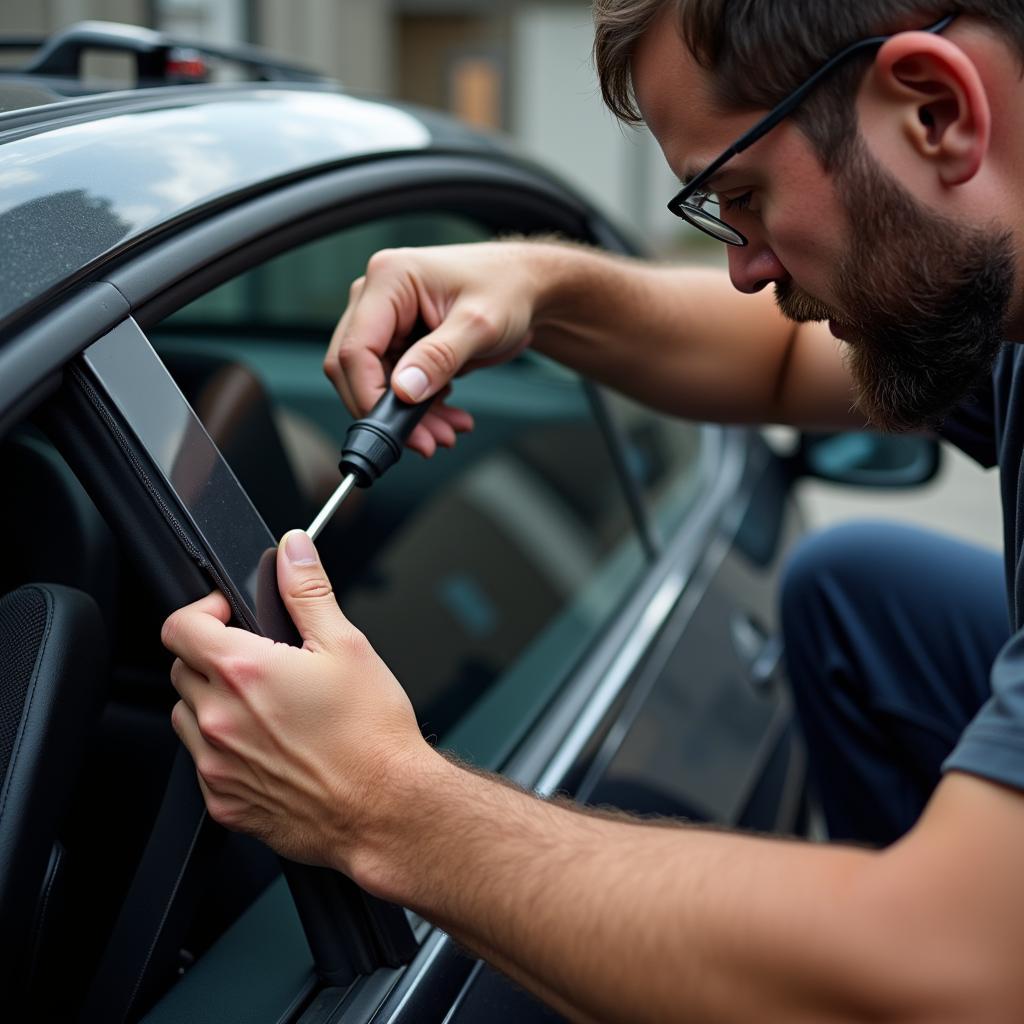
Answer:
594;0;1024;165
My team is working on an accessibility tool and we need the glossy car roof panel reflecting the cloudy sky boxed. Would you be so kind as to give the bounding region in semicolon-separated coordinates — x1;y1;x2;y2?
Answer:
0;83;509;335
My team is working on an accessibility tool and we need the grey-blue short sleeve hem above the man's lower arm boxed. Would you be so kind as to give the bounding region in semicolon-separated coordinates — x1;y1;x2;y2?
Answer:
942;630;1024;790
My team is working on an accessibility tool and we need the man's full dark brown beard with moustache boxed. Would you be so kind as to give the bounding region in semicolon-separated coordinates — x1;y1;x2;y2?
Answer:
775;140;1016;431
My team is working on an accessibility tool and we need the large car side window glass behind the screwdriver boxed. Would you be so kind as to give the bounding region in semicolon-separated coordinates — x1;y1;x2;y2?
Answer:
151;214;643;767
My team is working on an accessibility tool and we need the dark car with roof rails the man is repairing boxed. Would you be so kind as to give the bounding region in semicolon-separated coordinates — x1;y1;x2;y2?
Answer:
0;24;938;1024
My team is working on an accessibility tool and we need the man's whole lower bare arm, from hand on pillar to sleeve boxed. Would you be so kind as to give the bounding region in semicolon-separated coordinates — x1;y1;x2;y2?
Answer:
162;548;1024;1024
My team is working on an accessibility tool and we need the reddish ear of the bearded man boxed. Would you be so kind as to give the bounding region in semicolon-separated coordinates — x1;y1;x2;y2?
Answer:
868;32;992;185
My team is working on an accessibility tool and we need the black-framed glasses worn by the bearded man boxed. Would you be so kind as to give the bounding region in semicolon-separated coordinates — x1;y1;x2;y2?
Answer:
669;14;956;246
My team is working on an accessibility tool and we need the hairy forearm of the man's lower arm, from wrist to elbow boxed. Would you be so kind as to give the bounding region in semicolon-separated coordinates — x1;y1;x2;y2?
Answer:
350;758;958;1024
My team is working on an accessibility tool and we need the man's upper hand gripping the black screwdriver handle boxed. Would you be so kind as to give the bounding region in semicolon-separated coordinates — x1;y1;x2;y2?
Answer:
324;242;545;456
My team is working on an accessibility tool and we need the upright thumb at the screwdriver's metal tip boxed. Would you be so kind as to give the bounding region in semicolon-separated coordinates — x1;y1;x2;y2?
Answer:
278;529;350;650
